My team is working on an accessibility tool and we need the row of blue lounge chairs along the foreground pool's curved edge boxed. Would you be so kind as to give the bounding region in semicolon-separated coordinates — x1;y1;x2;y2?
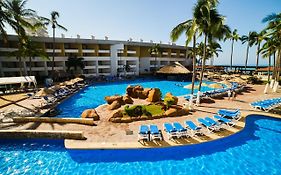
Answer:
138;109;241;141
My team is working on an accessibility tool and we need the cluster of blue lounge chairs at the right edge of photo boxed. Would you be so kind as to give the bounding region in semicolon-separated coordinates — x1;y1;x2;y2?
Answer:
250;98;281;112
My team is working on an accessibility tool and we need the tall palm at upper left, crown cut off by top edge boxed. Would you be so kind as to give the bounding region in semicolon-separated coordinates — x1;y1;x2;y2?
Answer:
5;0;37;76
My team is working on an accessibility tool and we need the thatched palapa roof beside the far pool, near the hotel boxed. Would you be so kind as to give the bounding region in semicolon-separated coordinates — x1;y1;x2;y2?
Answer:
157;62;191;74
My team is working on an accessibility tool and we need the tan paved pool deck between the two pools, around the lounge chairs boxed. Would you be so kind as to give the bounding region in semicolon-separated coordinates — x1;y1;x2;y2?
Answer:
0;85;281;149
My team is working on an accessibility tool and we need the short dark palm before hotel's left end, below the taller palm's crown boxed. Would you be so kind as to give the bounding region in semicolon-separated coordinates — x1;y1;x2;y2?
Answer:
24;38;49;76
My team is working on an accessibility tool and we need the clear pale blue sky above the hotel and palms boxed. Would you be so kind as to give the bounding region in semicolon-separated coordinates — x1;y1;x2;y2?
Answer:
8;0;281;65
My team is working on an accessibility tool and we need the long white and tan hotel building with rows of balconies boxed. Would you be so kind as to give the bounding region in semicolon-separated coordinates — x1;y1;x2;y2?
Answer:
0;35;192;77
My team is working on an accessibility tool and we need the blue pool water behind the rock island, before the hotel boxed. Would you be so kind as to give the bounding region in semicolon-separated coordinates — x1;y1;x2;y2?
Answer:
57;79;219;117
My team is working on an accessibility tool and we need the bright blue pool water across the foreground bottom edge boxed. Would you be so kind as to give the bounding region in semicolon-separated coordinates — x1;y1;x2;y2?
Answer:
0;115;281;175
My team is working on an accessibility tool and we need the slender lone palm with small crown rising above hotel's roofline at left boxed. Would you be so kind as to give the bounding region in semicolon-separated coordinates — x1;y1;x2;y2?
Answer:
41;11;67;73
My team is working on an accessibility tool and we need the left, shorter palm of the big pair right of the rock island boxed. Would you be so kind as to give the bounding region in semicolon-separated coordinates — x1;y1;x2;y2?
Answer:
170;18;199;101
